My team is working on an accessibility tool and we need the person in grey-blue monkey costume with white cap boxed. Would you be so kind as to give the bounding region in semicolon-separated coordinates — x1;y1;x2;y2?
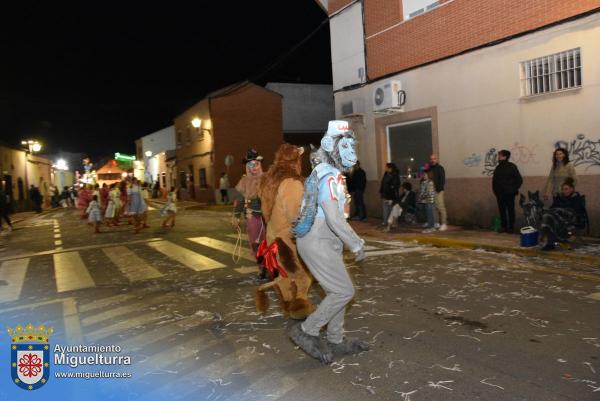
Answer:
290;121;369;363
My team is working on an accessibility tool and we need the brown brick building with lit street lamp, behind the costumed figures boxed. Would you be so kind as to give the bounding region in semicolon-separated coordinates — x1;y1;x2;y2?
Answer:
174;82;283;203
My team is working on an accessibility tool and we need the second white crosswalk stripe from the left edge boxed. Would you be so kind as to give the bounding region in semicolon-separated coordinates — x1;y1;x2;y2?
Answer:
53;252;96;292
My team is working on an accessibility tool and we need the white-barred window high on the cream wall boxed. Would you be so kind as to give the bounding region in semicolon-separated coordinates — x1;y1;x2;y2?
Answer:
521;48;582;97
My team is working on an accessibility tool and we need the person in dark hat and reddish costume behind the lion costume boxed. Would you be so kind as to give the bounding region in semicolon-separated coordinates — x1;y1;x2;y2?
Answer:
233;149;267;280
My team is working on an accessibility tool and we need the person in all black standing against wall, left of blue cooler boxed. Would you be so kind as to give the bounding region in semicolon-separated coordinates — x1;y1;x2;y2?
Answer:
492;150;523;233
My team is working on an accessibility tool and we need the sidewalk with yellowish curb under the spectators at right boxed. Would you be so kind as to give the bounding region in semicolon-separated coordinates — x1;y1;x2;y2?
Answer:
350;219;600;266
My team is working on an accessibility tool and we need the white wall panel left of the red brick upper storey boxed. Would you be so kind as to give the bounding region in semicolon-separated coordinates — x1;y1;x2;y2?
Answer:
329;2;366;90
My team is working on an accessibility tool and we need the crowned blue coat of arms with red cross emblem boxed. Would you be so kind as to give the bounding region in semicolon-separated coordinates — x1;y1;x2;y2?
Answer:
8;323;54;390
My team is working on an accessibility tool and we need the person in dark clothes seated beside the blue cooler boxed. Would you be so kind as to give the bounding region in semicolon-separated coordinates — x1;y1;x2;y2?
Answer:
541;177;587;251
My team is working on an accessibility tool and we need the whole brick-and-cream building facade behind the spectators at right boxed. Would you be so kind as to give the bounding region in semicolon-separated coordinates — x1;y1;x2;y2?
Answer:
317;0;600;231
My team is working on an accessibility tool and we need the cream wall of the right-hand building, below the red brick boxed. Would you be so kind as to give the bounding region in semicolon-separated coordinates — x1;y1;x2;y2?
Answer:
332;14;600;180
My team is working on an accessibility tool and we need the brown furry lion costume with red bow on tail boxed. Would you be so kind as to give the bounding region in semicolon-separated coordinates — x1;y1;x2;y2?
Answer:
256;143;315;319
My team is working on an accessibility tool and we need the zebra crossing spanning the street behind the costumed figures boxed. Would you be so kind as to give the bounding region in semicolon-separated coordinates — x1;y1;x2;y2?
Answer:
0;234;422;304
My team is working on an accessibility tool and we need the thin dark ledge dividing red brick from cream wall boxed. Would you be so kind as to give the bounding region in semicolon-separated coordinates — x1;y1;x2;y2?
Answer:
333;7;600;94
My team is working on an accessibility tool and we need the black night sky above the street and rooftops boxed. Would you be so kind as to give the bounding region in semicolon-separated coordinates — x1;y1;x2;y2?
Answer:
0;0;331;158
